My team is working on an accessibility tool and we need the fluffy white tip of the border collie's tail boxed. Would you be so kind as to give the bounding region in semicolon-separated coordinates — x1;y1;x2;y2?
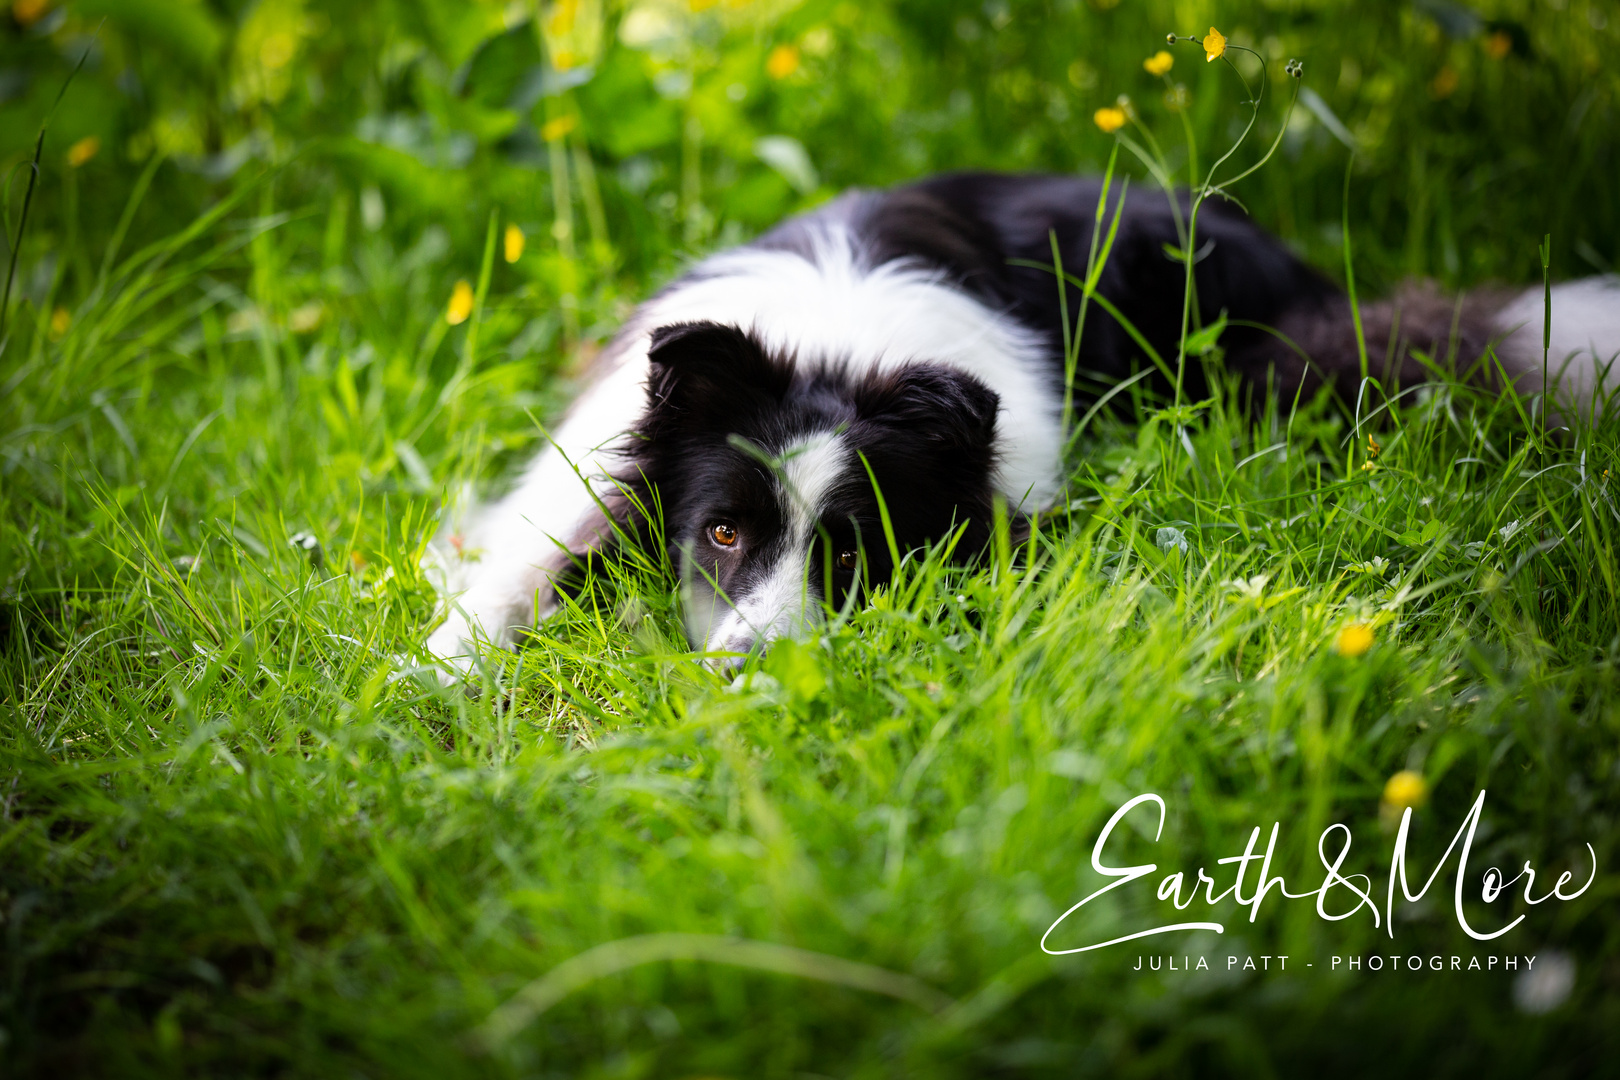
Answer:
1497;275;1620;410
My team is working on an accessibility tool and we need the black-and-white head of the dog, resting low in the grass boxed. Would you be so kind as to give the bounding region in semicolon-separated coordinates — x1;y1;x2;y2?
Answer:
630;322;998;667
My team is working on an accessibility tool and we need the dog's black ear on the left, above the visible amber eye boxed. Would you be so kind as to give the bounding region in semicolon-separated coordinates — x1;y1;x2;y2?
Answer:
643;322;792;437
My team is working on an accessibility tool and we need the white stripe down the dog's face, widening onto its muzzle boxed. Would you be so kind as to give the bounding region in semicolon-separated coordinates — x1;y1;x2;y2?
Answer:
708;432;857;651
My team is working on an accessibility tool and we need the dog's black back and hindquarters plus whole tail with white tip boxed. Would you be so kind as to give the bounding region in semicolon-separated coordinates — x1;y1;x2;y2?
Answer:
771;173;1620;408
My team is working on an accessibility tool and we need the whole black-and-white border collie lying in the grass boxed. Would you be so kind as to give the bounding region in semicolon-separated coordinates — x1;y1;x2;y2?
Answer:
428;173;1620;672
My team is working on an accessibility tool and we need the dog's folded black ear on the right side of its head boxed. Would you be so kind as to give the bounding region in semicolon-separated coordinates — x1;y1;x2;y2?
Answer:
854;364;1001;453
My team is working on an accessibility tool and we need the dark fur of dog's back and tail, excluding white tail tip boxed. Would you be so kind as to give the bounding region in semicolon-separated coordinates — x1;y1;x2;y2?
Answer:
797;173;1492;409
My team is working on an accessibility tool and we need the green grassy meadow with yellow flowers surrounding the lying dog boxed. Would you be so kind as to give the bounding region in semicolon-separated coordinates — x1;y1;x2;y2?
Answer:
0;0;1620;1078
